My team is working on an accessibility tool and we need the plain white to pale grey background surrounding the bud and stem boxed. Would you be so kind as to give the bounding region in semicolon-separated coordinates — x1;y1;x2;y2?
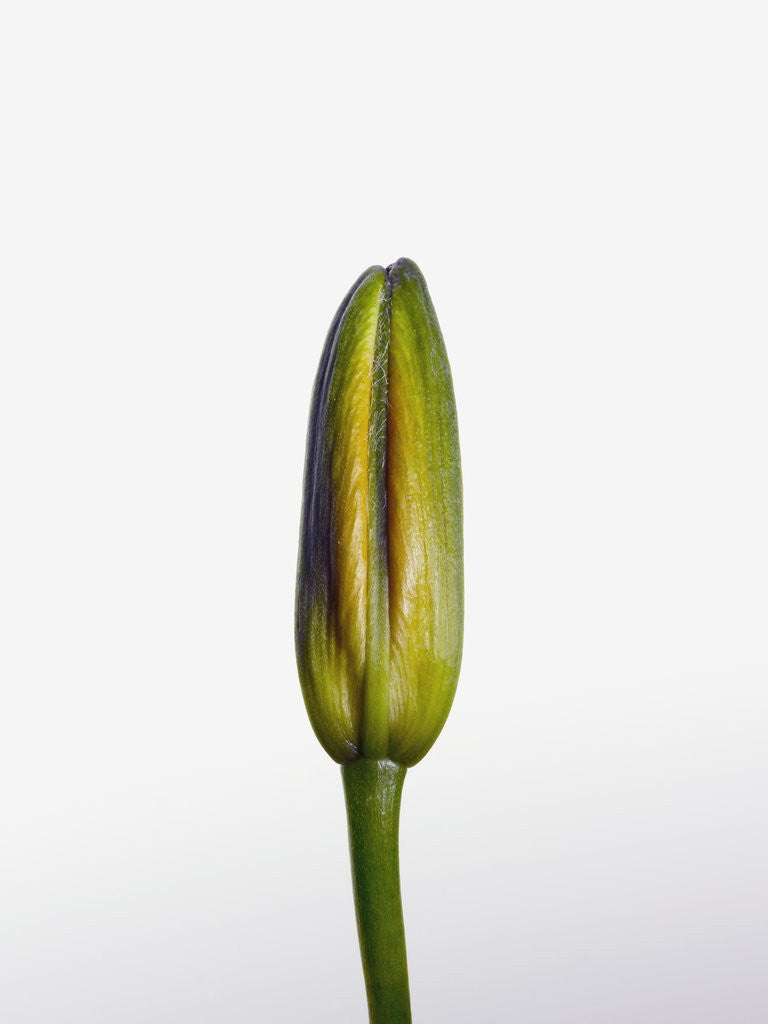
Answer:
0;0;768;1024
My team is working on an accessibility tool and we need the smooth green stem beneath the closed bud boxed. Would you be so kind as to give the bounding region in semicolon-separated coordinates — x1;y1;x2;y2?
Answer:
341;758;411;1024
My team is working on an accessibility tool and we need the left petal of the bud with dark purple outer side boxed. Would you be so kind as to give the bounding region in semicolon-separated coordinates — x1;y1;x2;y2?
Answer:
296;267;388;761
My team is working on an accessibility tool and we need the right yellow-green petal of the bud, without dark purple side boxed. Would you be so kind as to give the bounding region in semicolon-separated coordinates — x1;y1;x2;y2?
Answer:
387;260;464;765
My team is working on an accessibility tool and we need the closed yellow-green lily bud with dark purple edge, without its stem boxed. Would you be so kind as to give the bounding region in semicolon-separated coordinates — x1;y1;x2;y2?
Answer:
296;259;463;766
